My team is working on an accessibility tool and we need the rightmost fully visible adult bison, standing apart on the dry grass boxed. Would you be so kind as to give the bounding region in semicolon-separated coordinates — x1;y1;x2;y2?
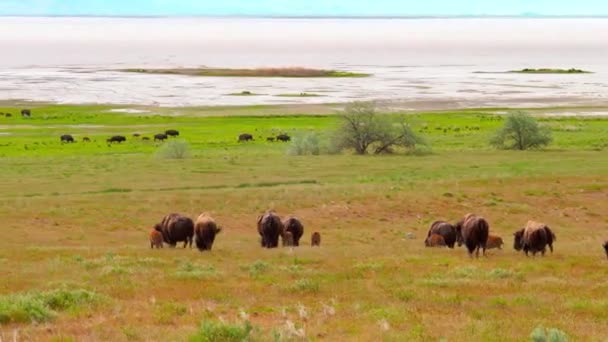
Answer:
513;221;555;256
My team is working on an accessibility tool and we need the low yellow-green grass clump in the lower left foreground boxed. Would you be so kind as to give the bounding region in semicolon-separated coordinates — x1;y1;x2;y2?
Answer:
0;289;103;324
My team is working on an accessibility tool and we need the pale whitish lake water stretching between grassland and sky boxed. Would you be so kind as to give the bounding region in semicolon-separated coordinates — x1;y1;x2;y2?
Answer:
0;18;608;106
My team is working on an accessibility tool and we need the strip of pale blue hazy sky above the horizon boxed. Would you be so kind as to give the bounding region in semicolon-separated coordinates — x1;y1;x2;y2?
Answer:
0;0;608;16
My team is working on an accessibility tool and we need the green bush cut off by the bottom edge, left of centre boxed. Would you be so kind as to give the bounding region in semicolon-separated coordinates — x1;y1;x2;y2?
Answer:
189;321;253;342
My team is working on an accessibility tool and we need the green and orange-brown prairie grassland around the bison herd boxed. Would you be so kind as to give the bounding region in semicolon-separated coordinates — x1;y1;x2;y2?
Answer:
0;106;608;341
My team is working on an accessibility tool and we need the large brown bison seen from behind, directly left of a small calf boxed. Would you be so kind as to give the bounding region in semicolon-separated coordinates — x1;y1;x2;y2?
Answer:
456;214;490;257
